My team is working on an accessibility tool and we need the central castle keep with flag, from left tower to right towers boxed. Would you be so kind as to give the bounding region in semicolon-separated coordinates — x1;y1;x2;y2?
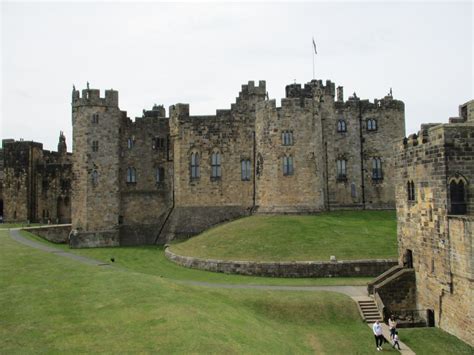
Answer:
67;80;405;246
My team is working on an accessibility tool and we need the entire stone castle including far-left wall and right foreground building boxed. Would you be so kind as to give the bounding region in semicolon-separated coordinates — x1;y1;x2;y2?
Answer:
0;80;474;345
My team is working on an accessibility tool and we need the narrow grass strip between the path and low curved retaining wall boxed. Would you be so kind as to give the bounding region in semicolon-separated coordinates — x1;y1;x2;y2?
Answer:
22;231;372;286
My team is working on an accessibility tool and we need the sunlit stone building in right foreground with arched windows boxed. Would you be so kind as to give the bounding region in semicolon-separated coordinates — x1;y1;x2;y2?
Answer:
396;106;474;345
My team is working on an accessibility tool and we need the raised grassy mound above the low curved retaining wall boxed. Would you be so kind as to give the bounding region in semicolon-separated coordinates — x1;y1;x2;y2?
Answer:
171;211;398;261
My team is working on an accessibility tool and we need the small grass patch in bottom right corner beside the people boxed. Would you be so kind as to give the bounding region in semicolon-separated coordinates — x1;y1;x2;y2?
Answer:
399;328;474;355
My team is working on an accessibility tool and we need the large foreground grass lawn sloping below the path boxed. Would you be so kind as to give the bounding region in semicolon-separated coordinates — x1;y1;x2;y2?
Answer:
0;231;388;354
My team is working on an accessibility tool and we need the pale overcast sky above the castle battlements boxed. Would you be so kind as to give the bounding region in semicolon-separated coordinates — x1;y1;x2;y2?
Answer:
0;1;474;150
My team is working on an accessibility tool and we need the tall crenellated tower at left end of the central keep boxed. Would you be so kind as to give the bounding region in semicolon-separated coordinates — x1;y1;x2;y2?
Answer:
71;85;124;247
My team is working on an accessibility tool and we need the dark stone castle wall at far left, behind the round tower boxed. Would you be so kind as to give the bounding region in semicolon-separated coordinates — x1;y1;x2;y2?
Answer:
1;138;72;223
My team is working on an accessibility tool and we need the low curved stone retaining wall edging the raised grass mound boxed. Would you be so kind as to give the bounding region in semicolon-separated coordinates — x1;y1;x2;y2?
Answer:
165;248;397;277
